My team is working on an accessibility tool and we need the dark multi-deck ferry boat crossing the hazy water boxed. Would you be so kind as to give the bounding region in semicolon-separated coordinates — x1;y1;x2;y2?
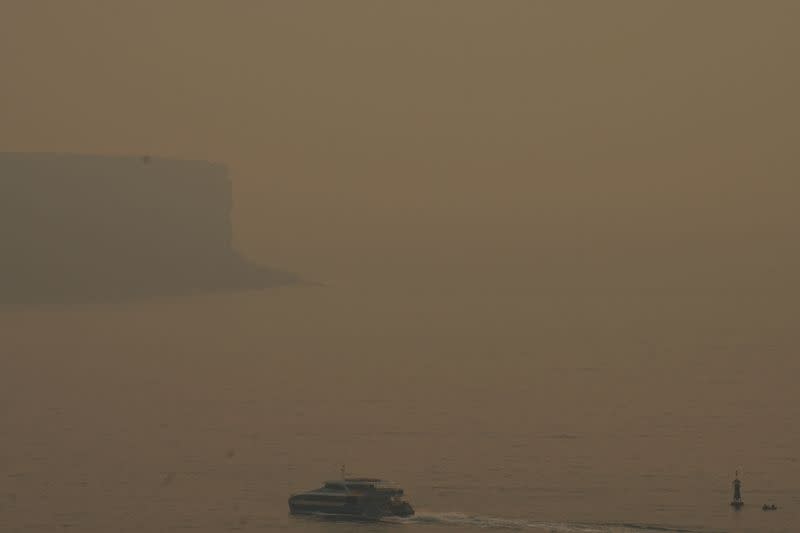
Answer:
289;469;414;520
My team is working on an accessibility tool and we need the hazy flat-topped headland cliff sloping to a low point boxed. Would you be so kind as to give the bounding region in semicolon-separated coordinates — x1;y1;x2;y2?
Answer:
0;154;292;302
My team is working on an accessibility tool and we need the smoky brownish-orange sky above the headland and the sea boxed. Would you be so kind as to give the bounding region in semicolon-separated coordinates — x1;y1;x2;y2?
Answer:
0;0;800;296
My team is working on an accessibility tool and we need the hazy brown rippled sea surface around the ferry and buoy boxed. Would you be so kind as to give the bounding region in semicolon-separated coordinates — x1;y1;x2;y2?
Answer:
0;275;800;533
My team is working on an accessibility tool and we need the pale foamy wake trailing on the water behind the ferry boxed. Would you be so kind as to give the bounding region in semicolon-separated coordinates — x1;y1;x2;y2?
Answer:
384;512;696;533
